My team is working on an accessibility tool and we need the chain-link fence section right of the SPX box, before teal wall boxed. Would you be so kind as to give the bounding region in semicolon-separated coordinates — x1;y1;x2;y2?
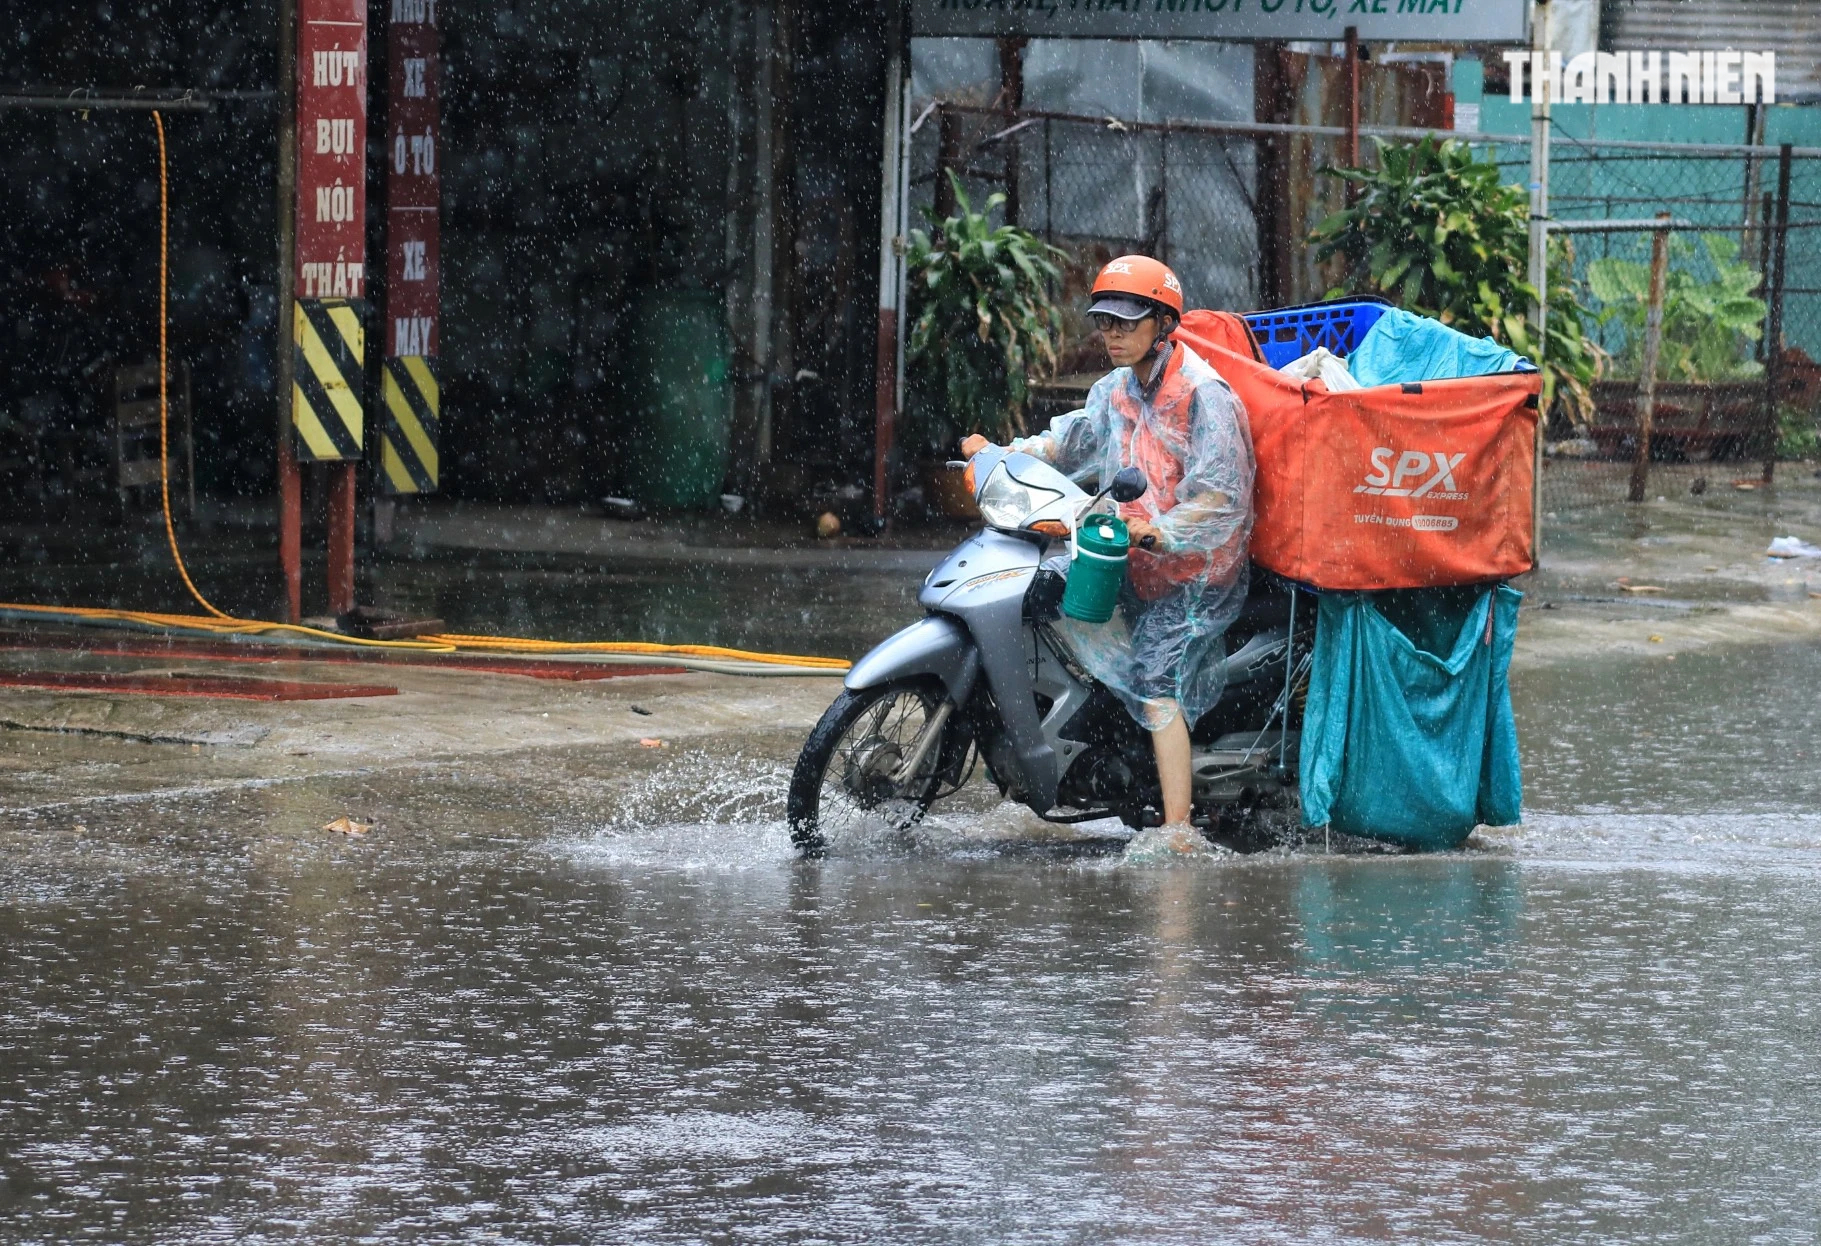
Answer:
1491;137;1821;525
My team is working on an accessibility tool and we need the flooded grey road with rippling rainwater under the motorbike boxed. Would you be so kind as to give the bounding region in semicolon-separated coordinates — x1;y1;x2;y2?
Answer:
0;645;1821;1242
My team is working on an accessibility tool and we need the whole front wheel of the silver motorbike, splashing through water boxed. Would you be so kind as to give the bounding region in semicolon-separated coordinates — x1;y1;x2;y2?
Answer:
785;679;967;856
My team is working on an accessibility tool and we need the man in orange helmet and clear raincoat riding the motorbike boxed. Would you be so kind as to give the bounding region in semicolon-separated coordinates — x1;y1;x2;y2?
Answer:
961;255;1253;853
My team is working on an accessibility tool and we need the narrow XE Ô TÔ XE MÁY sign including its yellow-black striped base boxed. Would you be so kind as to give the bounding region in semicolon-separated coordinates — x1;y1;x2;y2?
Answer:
379;0;443;494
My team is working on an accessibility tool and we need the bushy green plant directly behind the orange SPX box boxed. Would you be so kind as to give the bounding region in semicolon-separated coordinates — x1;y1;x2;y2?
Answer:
1309;135;1601;421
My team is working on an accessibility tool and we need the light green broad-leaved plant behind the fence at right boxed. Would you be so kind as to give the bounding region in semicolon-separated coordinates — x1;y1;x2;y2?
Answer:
1588;233;1766;381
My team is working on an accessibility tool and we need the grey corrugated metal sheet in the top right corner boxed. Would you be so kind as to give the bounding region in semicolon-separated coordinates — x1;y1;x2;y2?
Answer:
1608;0;1821;100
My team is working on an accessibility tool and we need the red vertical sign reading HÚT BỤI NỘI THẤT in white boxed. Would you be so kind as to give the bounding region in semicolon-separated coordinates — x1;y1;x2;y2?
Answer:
297;0;366;299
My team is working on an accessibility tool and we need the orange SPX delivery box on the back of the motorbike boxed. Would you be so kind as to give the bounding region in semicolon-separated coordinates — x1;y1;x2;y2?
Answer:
1176;312;1542;590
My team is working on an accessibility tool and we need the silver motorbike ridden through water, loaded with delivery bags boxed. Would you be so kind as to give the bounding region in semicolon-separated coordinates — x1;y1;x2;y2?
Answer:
787;446;1315;854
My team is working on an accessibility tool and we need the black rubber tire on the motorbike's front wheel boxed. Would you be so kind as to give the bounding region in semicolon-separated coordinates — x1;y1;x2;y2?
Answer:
785;679;967;856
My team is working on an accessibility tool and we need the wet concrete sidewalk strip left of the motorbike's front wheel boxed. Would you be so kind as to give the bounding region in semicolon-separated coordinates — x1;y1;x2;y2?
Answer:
0;650;841;820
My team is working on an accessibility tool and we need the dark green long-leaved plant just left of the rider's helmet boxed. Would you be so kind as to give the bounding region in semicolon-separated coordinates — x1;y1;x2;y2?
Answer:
905;171;1067;450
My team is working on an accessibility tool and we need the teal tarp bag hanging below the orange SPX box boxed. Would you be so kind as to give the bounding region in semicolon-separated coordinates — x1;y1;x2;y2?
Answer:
1302;585;1524;849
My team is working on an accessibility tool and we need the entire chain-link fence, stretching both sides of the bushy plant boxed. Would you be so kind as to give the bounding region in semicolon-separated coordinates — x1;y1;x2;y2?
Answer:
911;106;1821;525
